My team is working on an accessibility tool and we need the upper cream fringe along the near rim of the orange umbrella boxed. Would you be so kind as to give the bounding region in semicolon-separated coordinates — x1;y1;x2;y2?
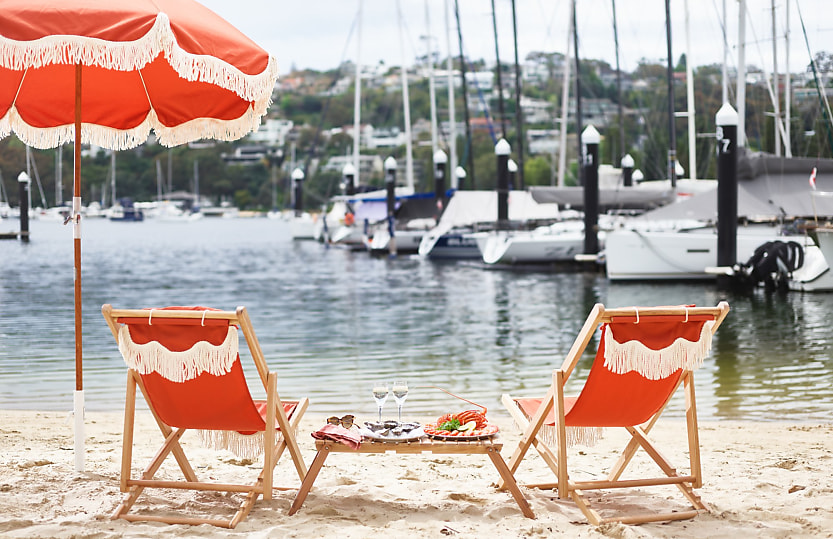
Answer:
0;13;278;104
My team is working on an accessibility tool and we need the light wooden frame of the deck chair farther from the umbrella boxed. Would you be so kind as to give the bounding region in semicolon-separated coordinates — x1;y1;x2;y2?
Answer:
501;302;729;526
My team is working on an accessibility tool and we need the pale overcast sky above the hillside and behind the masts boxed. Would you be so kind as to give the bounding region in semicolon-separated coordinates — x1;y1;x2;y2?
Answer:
201;0;833;74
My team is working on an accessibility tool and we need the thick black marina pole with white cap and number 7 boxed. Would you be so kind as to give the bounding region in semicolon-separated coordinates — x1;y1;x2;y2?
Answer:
715;103;738;286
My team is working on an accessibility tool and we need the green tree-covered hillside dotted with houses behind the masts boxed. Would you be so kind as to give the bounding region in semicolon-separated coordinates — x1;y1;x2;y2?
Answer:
0;53;833;209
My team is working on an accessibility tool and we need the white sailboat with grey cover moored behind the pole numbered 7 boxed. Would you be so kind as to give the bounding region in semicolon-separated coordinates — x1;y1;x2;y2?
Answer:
604;3;833;282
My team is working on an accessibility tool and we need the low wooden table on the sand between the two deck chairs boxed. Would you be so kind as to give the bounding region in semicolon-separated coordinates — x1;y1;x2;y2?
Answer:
289;436;535;518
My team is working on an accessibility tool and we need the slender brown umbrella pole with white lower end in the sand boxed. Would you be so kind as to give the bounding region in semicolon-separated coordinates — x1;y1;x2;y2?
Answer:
72;64;84;472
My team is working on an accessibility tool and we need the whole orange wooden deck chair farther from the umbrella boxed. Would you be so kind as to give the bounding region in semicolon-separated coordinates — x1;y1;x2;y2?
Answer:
501;302;729;525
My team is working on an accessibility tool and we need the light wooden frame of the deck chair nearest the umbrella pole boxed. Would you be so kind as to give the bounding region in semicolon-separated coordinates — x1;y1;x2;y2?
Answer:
101;304;309;528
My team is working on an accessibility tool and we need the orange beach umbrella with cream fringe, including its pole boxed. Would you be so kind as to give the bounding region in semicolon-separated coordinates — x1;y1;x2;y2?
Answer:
0;0;277;471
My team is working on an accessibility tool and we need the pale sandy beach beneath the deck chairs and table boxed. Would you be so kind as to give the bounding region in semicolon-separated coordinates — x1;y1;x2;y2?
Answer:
0;411;833;538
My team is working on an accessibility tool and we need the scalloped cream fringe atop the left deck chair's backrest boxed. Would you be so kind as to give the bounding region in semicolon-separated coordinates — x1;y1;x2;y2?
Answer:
119;325;238;382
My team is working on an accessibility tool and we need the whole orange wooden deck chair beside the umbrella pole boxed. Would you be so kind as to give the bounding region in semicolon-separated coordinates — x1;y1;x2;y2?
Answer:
101;304;309;528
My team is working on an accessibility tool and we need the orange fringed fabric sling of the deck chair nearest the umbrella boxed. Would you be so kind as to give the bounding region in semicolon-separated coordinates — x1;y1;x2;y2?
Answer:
119;307;295;458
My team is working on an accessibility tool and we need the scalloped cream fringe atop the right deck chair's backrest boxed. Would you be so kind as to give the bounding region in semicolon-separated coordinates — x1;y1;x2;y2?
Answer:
604;321;714;380
